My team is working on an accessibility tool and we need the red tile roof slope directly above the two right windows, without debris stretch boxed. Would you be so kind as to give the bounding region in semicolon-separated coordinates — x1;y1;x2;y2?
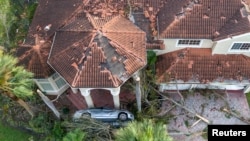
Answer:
158;0;250;39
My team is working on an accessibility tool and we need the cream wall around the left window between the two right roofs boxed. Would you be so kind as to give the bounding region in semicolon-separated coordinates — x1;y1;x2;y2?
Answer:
154;39;213;55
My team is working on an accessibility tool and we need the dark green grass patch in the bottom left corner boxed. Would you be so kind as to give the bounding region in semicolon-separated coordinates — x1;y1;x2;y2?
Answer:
0;122;32;141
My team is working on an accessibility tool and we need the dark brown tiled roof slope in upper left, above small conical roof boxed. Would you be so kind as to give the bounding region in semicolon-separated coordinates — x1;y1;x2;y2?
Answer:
26;0;82;44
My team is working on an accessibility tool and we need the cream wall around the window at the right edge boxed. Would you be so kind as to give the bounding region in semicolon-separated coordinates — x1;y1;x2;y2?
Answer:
212;33;250;57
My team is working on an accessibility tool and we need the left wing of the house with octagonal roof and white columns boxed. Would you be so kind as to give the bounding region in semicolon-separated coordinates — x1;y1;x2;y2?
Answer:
17;0;146;108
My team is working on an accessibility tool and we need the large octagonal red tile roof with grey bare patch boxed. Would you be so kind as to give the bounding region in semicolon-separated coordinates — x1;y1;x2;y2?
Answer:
48;11;146;88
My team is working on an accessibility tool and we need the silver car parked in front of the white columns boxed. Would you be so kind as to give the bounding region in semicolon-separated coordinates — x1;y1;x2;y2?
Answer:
73;107;134;121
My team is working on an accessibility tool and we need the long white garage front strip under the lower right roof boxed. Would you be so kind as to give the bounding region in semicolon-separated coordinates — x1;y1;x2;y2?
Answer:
159;80;250;92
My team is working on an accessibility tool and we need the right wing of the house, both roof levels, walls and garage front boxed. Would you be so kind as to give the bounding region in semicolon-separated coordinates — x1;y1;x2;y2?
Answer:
129;0;250;93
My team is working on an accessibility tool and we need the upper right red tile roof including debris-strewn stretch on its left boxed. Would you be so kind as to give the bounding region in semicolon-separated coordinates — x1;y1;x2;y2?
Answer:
130;0;250;40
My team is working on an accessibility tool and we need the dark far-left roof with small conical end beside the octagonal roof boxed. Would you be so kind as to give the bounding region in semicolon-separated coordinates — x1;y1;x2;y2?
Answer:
16;0;82;78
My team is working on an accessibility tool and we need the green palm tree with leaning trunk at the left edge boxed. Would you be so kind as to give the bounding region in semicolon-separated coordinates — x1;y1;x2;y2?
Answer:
0;50;34;117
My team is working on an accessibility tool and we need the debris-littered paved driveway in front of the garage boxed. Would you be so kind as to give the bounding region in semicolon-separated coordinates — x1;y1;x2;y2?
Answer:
161;90;250;141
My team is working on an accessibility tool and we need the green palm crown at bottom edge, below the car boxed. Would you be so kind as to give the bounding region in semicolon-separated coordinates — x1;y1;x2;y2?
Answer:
115;119;172;141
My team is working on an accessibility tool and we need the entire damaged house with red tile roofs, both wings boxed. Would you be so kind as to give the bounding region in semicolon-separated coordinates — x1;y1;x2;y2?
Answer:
17;0;250;108
